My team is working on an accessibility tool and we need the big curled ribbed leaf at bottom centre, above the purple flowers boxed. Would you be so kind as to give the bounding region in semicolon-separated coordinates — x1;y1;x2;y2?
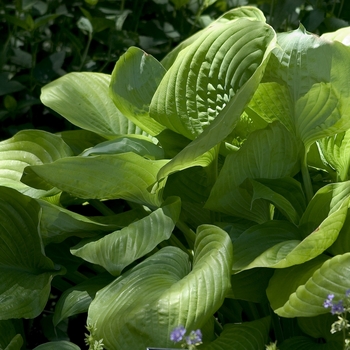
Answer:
87;225;232;350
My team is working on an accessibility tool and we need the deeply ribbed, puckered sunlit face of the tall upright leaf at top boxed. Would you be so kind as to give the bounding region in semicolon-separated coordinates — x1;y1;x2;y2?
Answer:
150;18;274;142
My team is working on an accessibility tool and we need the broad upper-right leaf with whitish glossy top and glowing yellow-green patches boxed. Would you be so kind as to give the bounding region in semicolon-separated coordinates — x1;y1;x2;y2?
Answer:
249;26;350;150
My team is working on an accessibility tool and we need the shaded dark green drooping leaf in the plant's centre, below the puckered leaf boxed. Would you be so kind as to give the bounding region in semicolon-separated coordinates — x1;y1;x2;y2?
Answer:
206;123;299;222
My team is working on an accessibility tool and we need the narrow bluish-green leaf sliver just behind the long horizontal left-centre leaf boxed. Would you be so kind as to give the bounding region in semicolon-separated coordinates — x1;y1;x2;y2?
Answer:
81;135;164;159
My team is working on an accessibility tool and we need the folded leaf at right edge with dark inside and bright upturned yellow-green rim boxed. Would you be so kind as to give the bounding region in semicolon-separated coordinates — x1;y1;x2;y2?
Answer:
233;183;349;271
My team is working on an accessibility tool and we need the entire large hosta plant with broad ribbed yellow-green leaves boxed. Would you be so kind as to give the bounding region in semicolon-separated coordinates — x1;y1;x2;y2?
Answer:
0;7;350;350
